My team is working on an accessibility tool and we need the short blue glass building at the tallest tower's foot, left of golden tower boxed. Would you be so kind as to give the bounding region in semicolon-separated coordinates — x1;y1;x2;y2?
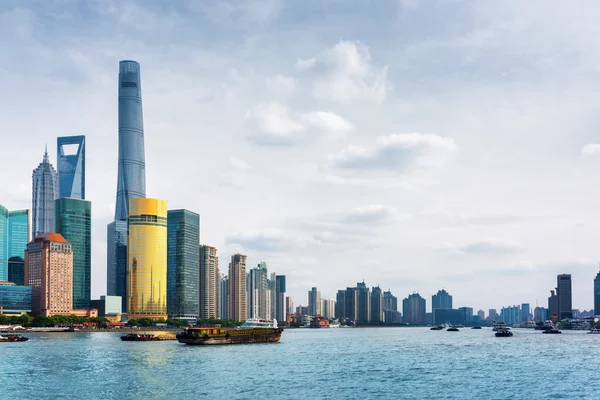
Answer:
106;221;127;313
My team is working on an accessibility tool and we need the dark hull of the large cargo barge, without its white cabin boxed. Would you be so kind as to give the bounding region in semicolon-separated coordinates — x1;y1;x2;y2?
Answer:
177;328;283;345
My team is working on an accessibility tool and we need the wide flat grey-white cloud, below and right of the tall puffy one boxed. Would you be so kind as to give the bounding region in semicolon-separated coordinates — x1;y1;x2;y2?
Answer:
327;133;458;172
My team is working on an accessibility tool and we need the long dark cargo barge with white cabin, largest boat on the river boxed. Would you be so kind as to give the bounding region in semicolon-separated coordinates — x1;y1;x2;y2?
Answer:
177;318;283;345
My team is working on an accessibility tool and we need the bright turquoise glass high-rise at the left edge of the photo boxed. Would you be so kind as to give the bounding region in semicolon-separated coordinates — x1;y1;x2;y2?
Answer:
0;205;29;285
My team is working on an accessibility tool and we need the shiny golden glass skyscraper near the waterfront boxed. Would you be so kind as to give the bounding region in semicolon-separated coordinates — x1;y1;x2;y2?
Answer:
127;198;167;319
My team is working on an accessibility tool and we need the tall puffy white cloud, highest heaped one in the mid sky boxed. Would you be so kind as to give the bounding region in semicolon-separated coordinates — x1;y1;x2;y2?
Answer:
313;40;391;103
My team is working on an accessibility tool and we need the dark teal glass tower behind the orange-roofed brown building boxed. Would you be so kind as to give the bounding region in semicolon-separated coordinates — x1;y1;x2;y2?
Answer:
55;198;92;309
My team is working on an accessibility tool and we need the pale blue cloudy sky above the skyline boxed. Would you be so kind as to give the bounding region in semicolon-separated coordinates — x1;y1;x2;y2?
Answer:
0;0;600;315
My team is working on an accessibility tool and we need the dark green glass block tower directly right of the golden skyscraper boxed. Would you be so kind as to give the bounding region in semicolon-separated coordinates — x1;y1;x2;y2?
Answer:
167;210;199;320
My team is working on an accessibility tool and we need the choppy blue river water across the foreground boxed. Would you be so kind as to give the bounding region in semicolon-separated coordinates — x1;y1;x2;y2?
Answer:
0;328;600;400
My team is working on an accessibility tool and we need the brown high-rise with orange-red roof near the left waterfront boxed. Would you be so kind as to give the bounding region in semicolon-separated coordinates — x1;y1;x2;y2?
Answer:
25;232;73;317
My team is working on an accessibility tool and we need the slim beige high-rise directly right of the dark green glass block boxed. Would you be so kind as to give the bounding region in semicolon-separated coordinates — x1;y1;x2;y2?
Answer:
199;244;219;319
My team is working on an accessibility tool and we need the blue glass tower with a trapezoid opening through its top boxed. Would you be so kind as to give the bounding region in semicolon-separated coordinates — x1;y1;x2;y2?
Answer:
56;135;85;199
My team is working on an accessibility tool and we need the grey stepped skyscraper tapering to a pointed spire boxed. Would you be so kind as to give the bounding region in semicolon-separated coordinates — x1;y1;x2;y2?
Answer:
31;148;58;238
